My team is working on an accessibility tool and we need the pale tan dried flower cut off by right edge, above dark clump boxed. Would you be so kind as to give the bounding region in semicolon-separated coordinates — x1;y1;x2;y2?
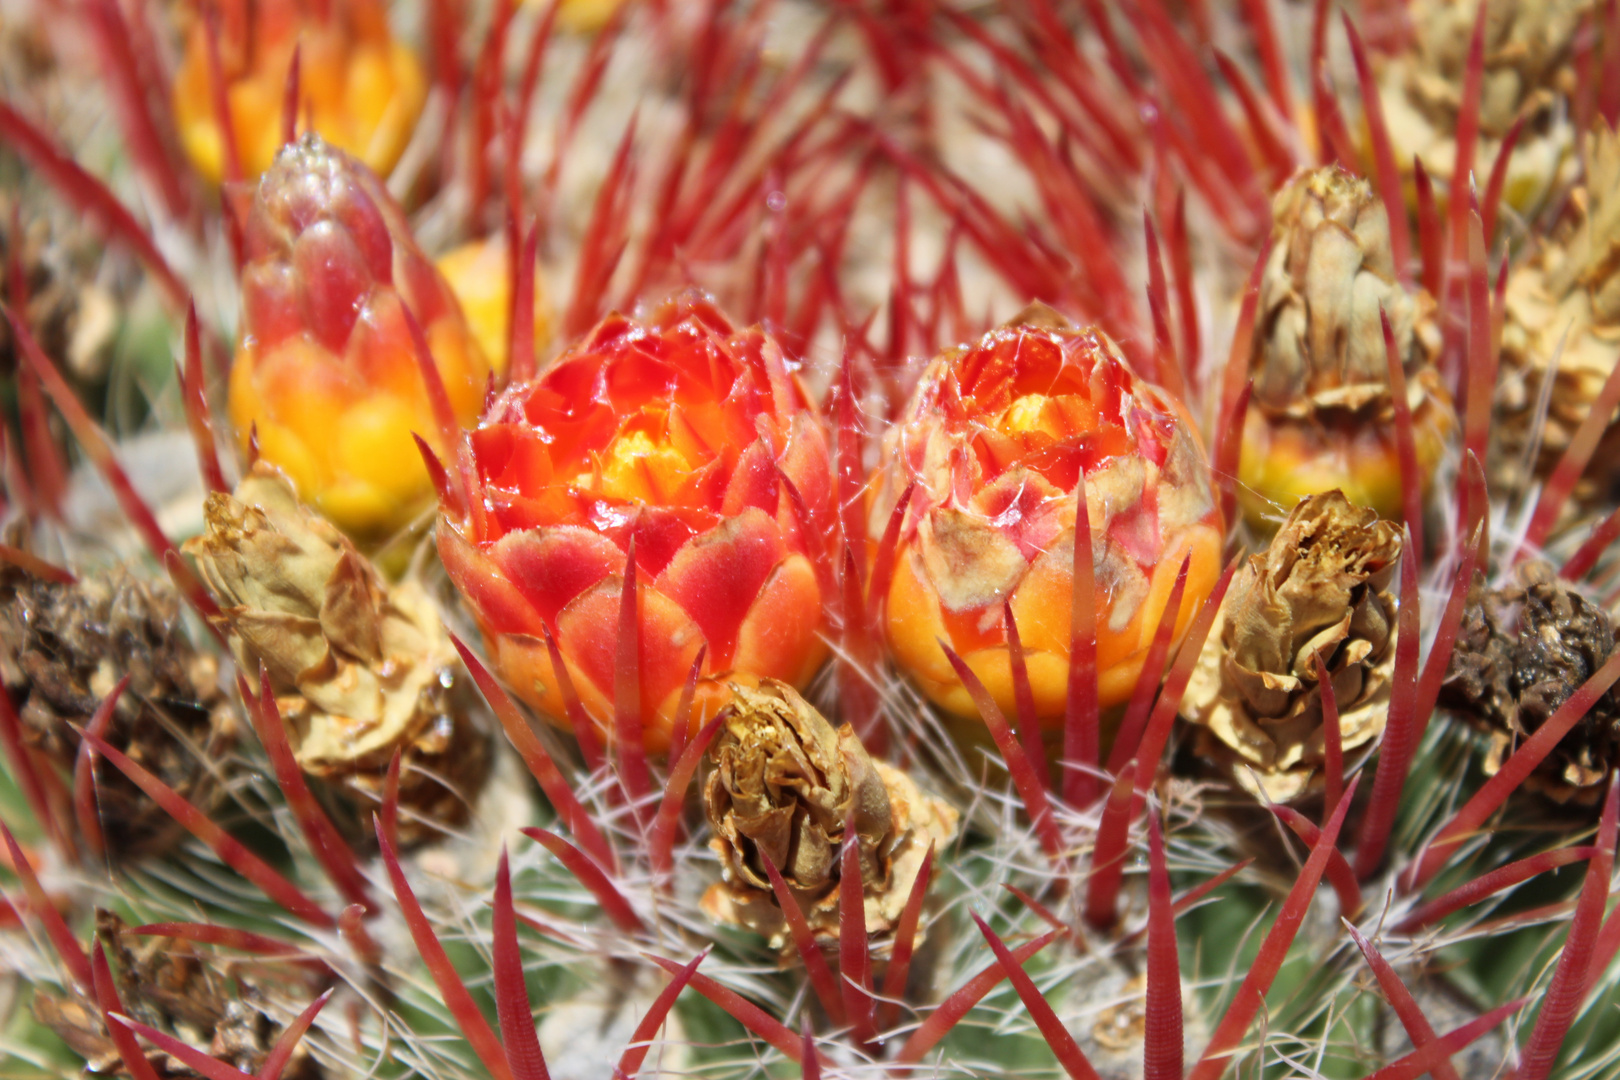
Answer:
1490;123;1620;505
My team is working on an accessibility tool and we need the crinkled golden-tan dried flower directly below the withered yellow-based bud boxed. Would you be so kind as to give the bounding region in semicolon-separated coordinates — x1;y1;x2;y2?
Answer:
1183;491;1401;801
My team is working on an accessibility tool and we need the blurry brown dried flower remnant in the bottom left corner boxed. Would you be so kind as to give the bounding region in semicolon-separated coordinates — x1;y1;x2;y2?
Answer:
34;910;326;1080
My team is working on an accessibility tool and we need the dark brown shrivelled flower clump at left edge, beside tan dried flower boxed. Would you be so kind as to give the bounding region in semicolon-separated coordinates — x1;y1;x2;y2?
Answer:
0;567;238;857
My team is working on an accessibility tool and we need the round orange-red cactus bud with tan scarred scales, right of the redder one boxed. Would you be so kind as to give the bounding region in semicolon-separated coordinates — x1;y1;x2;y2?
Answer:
873;308;1221;725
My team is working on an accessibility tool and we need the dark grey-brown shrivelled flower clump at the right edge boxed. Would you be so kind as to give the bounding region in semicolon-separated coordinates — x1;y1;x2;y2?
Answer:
1440;562;1620;805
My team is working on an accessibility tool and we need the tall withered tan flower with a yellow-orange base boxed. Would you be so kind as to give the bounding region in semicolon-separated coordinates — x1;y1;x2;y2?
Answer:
1238;165;1458;528
